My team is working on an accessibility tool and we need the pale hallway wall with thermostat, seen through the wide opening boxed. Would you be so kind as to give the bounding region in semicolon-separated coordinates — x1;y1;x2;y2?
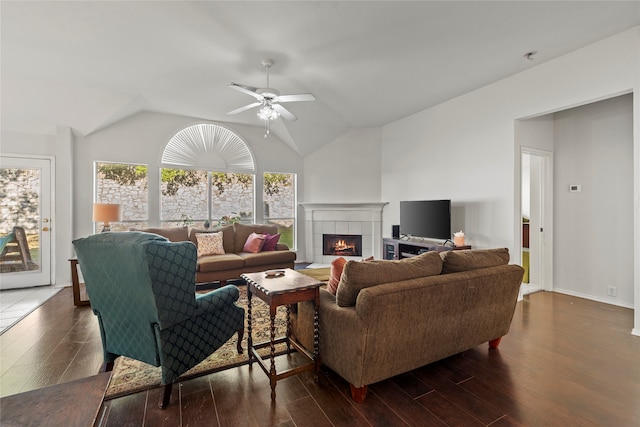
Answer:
553;95;634;307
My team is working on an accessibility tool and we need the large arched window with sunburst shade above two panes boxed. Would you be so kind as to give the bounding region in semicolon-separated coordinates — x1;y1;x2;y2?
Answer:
160;124;256;227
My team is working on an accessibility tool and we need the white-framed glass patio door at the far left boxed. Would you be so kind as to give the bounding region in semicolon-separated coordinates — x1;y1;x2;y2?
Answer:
0;155;53;289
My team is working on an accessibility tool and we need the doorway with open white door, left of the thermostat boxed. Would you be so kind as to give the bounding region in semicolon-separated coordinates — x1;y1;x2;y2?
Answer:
520;147;553;295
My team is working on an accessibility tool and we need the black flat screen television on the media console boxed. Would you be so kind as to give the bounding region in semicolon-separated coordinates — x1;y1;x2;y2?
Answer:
400;200;451;240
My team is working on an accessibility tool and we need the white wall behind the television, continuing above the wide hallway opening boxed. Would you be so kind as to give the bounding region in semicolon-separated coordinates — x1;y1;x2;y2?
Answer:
381;27;640;334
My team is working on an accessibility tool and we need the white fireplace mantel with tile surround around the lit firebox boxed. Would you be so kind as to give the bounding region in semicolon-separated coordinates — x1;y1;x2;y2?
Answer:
300;202;388;264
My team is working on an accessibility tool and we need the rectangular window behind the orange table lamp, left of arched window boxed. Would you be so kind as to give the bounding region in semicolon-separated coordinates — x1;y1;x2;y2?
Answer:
94;162;148;232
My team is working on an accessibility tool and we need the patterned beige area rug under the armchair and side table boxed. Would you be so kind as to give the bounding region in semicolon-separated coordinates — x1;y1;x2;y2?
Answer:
105;269;328;400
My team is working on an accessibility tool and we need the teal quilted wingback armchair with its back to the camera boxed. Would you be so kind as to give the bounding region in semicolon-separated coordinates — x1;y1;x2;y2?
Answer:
73;232;244;408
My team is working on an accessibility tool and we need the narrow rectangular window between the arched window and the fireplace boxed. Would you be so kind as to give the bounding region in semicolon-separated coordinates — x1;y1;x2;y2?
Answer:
262;172;296;249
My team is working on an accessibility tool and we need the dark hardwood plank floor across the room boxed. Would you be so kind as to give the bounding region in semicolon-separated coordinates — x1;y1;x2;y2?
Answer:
0;288;640;427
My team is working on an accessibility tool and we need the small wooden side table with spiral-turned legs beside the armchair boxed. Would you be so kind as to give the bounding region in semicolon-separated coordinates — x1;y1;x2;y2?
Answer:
242;268;322;399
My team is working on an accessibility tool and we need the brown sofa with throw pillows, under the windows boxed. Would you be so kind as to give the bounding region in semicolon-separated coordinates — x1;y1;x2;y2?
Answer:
132;223;296;283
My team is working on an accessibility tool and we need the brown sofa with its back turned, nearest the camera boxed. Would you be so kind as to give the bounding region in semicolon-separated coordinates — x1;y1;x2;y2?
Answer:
292;249;524;402
